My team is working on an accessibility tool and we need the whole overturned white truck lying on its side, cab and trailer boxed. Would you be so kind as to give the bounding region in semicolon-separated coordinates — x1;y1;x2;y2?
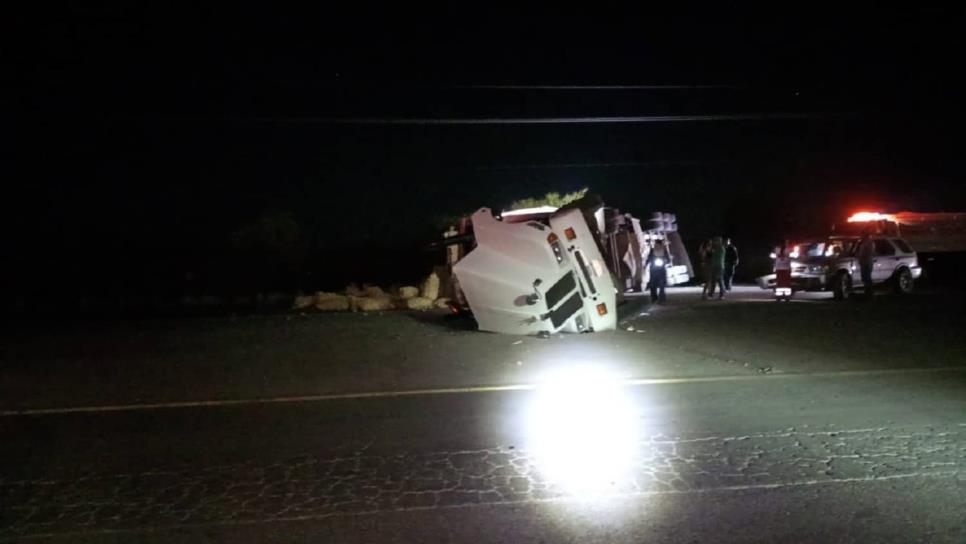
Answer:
446;196;692;335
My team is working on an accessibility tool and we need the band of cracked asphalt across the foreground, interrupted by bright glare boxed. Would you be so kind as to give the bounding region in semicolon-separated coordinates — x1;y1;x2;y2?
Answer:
0;423;966;536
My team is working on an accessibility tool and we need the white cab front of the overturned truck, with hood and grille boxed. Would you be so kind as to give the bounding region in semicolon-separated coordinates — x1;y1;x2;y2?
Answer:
453;208;617;335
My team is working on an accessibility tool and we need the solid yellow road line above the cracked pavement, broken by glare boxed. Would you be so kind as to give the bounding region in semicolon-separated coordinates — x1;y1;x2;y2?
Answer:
0;366;966;417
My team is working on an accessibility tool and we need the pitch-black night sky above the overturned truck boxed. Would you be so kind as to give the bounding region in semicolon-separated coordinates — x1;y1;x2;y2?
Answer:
4;7;966;298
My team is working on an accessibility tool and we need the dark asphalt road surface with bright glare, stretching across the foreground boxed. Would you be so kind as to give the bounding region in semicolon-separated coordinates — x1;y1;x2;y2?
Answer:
0;288;966;542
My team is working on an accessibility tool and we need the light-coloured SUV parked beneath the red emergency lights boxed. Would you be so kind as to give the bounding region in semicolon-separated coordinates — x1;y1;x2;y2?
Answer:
758;236;922;300
